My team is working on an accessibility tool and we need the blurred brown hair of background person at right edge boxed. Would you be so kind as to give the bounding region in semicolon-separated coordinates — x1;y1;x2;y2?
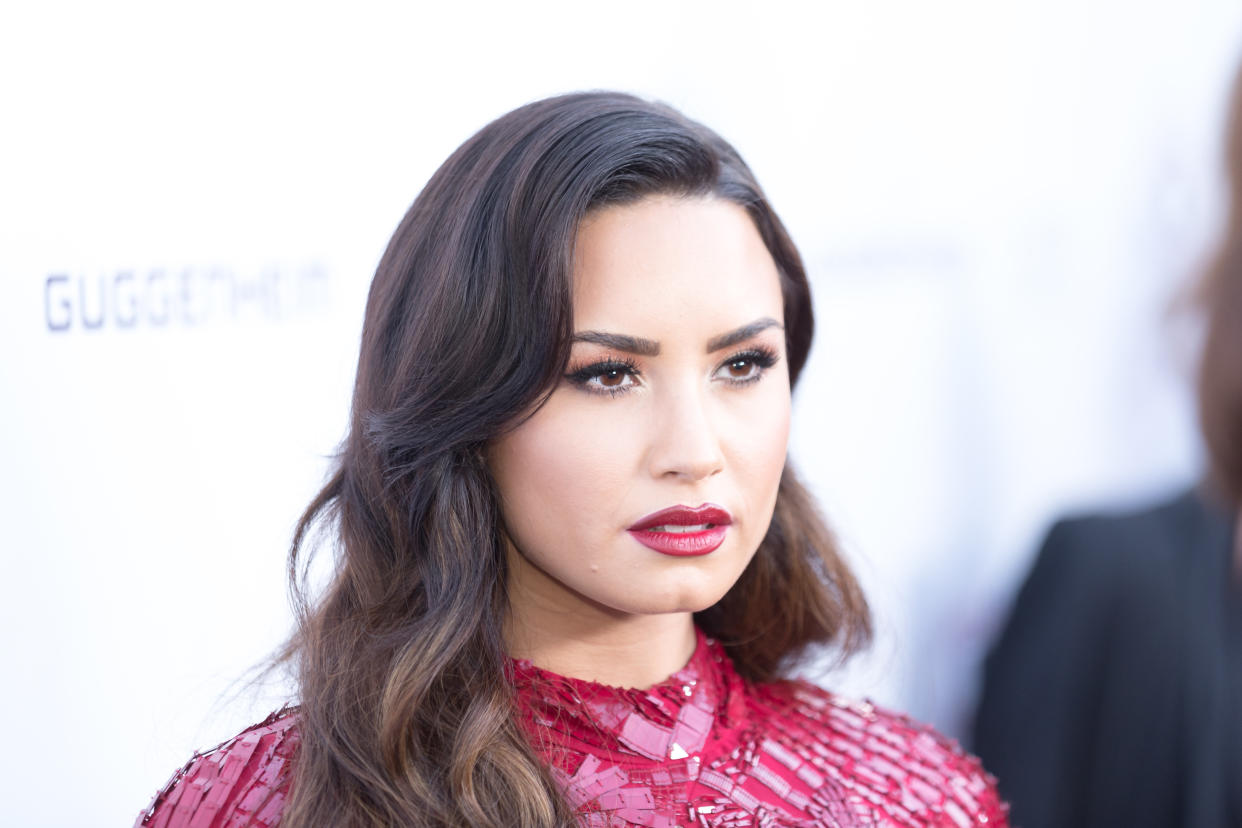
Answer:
1199;67;1242;506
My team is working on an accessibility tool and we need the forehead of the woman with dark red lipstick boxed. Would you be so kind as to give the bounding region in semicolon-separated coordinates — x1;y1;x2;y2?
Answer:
574;196;784;334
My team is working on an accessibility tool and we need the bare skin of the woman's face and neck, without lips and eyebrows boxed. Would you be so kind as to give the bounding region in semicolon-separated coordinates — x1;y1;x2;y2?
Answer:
489;196;790;688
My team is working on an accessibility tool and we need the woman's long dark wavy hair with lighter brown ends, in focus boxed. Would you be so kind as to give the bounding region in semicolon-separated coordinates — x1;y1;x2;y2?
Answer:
282;92;871;828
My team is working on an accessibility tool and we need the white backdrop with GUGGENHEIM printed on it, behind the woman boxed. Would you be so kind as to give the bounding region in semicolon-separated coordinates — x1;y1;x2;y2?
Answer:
0;0;1242;827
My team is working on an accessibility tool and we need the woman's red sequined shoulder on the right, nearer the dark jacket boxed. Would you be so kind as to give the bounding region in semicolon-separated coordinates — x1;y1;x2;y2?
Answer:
773;682;1009;828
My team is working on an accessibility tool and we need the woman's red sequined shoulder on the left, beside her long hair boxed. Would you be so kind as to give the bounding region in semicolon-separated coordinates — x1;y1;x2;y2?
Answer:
134;708;298;828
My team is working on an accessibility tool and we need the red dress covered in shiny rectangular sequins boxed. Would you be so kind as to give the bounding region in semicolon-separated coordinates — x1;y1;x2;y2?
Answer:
138;633;1009;828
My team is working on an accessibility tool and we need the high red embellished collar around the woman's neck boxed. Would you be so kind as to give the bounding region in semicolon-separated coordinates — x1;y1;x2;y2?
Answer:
508;628;745;763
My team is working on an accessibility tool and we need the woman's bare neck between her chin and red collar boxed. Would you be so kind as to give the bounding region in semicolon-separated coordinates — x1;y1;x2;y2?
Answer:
504;543;696;688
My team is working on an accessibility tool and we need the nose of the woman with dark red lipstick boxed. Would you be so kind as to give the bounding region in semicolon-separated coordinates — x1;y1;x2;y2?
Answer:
648;389;724;483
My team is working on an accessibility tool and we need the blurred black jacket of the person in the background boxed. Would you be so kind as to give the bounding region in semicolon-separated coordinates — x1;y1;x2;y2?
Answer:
974;490;1242;828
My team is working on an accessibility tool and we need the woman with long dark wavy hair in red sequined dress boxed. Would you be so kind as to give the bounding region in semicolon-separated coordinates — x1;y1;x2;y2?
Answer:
140;93;1005;827
